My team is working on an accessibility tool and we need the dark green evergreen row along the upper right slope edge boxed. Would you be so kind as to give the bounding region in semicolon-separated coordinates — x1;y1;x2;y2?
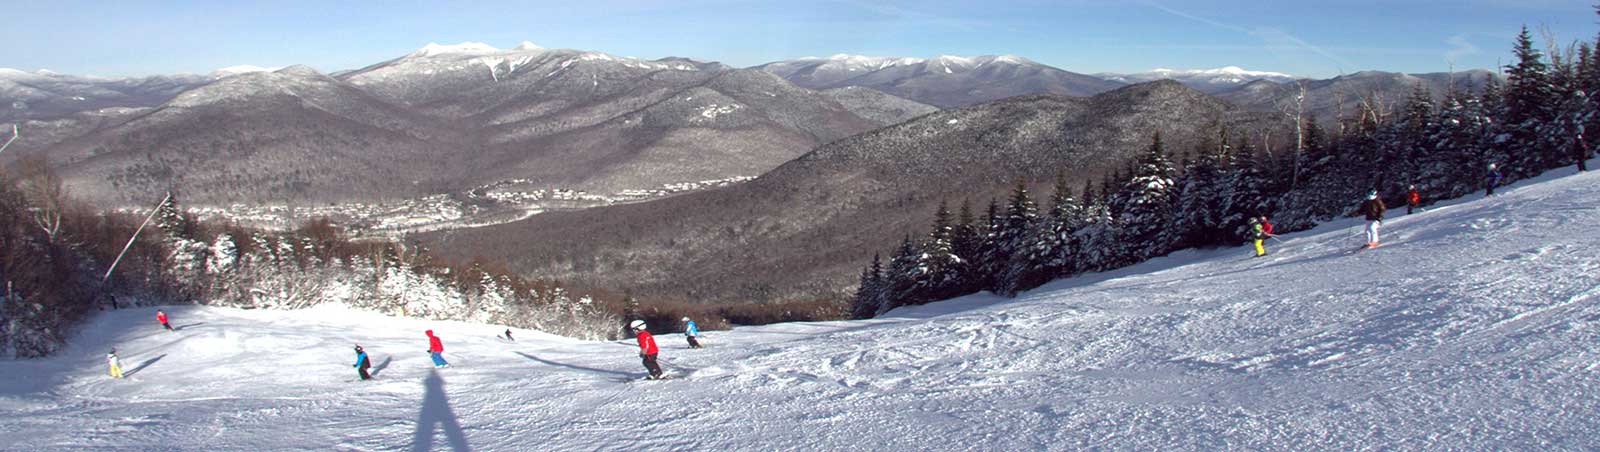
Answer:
850;23;1600;319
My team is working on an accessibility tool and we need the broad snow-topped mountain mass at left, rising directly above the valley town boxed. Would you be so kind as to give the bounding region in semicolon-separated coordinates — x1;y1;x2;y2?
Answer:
6;43;936;204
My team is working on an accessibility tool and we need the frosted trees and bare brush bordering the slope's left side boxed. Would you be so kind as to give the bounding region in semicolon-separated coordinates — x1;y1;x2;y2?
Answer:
0;169;622;357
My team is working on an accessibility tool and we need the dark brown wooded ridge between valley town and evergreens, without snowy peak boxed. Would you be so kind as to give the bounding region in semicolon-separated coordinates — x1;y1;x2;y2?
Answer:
424;80;1278;303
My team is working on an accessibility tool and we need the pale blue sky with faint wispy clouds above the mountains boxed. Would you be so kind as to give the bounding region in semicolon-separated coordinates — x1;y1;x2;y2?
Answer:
0;0;1600;77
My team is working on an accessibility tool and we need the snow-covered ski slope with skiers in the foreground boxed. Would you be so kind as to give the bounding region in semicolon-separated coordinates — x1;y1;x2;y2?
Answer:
0;166;1600;450
